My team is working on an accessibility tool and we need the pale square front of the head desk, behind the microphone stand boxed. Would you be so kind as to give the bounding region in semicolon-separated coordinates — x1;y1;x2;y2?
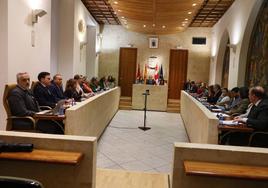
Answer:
132;84;168;111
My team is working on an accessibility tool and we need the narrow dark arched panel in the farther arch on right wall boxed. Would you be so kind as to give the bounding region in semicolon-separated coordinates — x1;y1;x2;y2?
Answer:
221;39;230;88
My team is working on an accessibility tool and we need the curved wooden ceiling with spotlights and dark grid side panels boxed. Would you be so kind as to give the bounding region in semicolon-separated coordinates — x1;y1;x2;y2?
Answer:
82;0;234;34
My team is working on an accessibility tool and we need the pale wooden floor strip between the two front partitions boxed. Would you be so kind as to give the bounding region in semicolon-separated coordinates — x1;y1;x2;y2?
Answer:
96;168;169;188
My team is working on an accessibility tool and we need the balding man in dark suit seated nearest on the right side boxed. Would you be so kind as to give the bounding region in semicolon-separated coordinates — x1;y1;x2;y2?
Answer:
226;86;268;147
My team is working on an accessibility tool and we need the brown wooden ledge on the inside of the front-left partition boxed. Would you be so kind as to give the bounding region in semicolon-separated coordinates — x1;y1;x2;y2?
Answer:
0;149;83;165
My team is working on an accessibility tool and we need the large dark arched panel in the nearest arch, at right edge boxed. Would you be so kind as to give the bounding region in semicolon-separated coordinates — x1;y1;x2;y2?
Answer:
245;1;268;89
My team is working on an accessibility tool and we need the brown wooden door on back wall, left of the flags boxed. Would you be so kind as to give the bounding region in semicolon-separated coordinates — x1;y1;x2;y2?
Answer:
118;48;137;97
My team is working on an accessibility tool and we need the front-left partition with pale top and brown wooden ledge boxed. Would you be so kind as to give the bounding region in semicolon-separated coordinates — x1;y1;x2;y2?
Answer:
0;131;97;188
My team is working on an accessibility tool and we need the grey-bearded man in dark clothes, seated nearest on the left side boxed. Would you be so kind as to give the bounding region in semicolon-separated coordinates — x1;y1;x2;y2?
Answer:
8;72;64;134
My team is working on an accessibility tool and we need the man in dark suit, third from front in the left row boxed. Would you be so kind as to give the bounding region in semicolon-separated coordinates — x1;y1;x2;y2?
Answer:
49;74;65;102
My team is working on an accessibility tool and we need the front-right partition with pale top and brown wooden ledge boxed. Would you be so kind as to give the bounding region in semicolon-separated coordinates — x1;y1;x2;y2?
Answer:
171;143;268;188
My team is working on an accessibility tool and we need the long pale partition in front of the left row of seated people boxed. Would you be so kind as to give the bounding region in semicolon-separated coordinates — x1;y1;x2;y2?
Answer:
65;87;120;138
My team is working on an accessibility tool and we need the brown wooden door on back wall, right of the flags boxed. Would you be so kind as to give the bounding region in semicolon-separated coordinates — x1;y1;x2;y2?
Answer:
168;49;188;99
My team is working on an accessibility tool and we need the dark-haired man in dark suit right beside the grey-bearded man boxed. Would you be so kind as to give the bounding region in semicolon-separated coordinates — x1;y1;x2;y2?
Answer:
33;72;57;108
